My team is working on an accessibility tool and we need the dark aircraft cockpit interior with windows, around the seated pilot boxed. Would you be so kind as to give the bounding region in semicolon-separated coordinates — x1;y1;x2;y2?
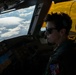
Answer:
0;0;76;75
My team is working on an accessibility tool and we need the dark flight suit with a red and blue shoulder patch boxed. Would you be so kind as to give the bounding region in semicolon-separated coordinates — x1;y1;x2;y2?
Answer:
44;40;76;75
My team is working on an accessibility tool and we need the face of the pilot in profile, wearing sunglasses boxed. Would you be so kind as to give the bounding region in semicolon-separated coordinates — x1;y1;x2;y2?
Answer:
46;22;60;43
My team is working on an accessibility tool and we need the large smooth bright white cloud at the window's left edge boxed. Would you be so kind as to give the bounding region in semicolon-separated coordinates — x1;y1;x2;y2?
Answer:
0;17;23;26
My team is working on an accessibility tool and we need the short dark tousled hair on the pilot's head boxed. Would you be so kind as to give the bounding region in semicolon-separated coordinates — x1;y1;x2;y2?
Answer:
45;12;72;34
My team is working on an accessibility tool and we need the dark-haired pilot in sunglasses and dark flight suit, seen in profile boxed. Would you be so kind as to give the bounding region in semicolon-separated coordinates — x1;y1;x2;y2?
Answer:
44;12;76;75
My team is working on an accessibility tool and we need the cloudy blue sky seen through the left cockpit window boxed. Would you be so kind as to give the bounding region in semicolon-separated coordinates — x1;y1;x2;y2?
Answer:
0;6;35;41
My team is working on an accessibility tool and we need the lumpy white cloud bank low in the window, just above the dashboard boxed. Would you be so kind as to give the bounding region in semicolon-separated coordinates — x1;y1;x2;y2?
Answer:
1;24;28;38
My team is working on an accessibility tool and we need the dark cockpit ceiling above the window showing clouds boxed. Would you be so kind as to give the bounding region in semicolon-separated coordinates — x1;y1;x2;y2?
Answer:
0;0;72;12
